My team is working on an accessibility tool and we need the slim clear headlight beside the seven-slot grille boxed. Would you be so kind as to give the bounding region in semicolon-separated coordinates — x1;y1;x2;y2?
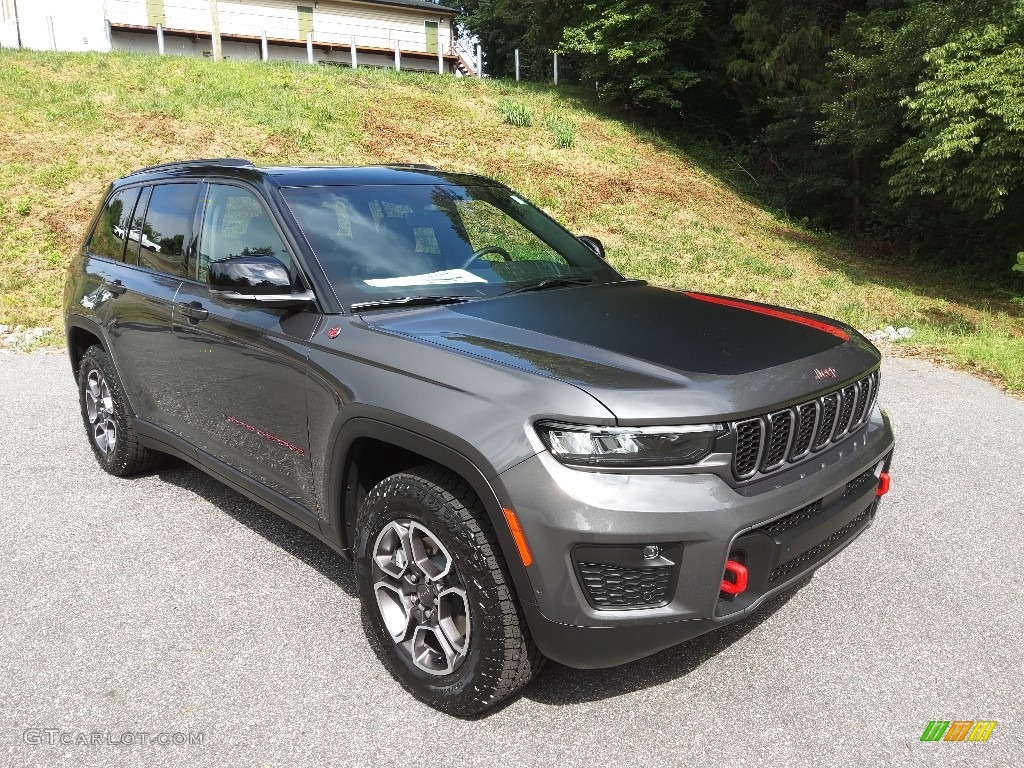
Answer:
537;422;725;467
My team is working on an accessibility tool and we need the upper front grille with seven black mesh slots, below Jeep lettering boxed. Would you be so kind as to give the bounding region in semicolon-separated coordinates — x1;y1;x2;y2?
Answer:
729;371;879;480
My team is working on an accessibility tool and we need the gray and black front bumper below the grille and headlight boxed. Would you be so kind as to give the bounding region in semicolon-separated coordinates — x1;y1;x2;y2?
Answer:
500;410;894;669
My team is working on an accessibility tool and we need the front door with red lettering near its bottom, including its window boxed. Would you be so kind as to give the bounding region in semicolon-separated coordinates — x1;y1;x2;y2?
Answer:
174;181;321;524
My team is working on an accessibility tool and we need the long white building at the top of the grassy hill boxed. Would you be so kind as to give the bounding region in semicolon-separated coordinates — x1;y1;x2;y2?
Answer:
0;0;469;74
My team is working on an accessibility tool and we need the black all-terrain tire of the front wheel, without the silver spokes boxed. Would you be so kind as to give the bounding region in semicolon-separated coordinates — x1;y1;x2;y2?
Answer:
354;465;544;717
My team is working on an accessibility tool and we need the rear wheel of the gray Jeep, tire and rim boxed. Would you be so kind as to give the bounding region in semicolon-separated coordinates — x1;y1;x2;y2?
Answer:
78;345;163;477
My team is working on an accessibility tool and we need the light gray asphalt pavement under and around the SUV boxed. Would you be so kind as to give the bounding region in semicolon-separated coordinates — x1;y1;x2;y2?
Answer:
0;354;1024;768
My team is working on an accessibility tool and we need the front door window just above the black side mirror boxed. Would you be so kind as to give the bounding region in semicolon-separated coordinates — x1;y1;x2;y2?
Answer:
199;184;295;283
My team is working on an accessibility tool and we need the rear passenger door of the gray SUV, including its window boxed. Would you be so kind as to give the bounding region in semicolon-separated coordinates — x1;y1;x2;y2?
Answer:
102;182;199;432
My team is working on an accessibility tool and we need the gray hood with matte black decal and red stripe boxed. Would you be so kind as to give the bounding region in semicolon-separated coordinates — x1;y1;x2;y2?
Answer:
364;282;880;424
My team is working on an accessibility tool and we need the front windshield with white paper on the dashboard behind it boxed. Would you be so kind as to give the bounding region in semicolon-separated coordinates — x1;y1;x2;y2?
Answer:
284;184;622;305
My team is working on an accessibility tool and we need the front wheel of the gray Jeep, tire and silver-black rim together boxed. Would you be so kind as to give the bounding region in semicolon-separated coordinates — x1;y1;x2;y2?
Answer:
355;466;542;717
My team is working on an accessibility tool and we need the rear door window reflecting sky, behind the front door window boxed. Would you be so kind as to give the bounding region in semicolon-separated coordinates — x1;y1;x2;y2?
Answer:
138;184;198;276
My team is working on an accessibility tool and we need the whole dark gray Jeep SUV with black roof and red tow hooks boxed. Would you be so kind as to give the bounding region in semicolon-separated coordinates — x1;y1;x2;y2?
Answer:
65;160;893;716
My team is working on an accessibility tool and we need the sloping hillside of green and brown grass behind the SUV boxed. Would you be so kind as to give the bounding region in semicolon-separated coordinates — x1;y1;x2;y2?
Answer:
0;50;1024;391
